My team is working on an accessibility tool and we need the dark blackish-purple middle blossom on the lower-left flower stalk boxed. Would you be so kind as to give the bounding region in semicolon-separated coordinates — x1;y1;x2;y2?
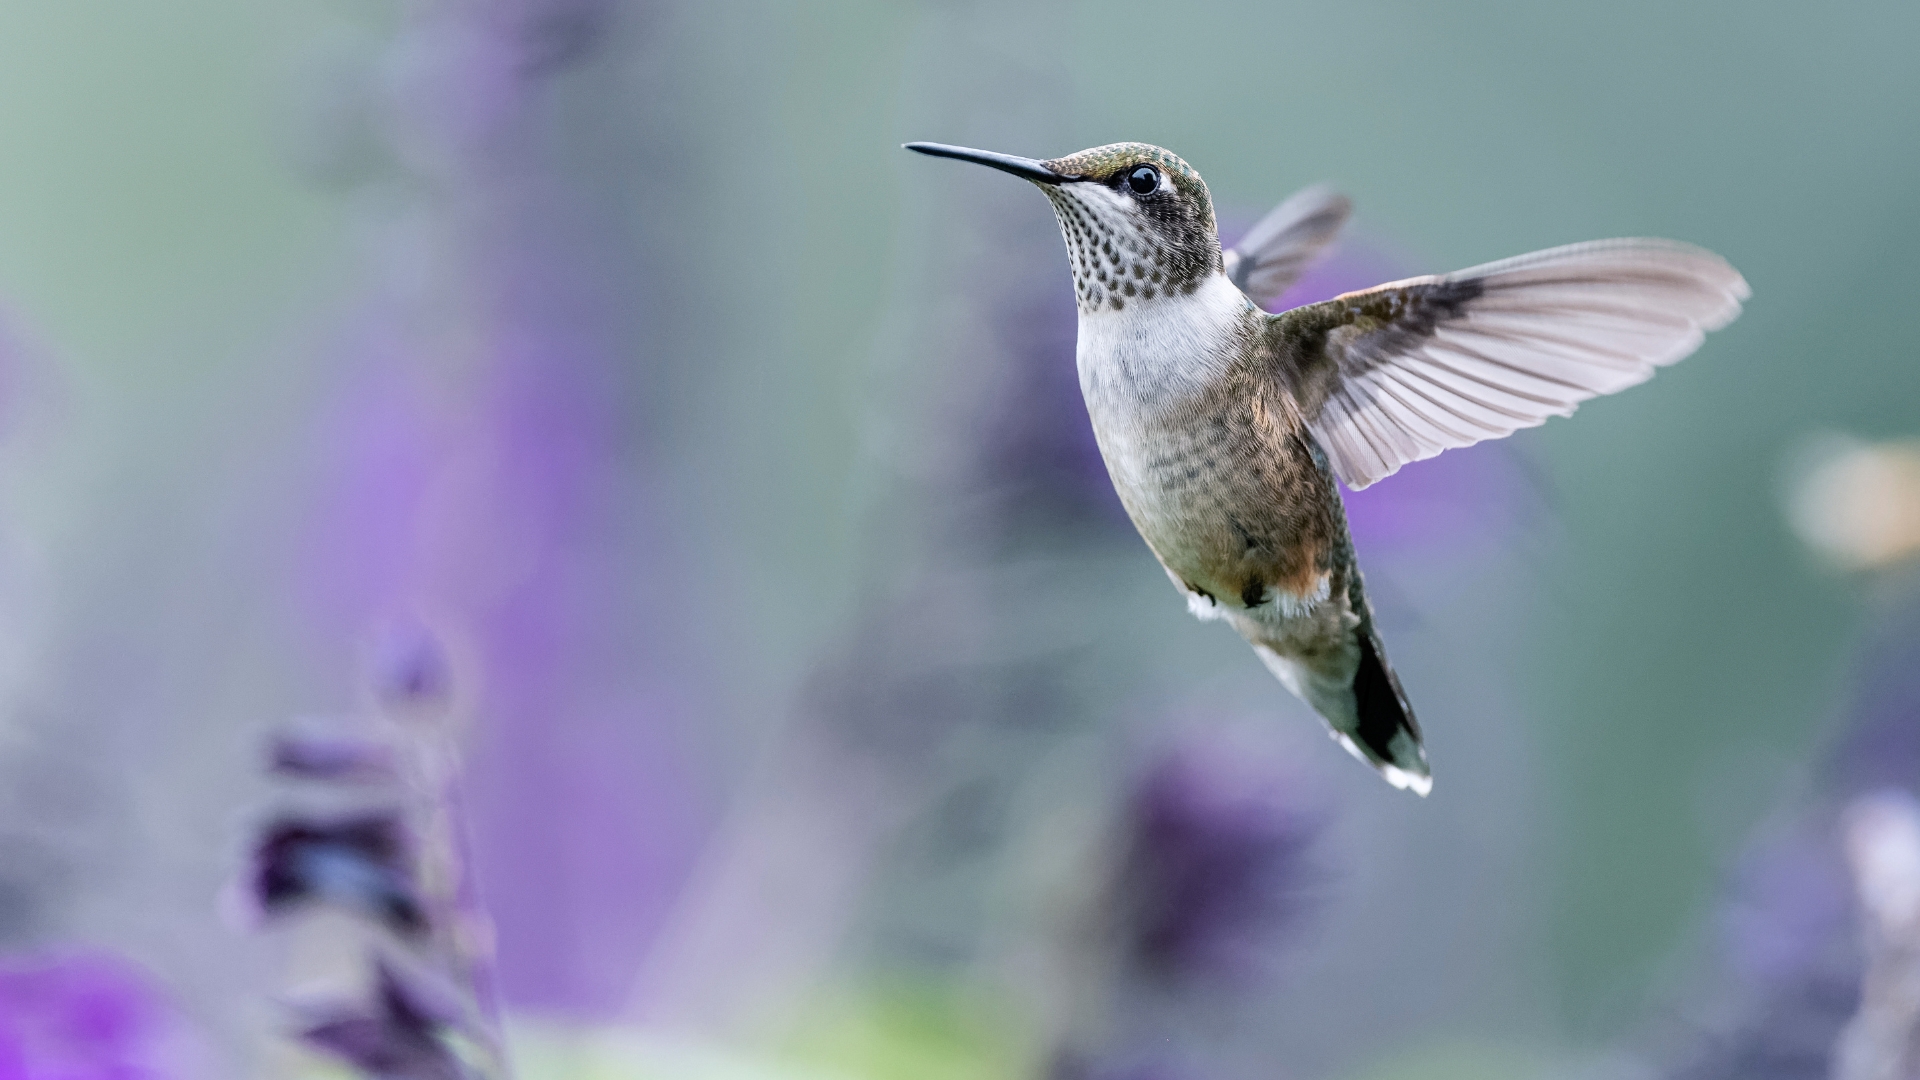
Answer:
253;813;426;934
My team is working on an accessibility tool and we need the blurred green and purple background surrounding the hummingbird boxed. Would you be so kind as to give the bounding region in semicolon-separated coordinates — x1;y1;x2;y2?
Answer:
0;0;1920;1080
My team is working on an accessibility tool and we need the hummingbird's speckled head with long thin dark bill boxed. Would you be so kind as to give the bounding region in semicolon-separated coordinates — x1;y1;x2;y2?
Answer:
906;142;1223;313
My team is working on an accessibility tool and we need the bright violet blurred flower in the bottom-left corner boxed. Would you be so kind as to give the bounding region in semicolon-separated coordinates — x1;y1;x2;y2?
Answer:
0;953;184;1080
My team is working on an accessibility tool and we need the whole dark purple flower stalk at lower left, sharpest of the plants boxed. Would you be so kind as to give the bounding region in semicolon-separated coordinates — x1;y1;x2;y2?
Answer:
242;630;509;1080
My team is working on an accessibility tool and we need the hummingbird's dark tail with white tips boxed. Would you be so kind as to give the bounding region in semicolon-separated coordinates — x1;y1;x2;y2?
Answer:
1254;619;1434;796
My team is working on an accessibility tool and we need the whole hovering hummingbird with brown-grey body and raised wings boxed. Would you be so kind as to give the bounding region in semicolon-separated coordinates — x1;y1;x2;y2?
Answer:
904;142;1749;796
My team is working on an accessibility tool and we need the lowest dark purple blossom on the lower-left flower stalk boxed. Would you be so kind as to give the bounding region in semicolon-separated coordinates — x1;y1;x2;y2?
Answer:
300;961;472;1080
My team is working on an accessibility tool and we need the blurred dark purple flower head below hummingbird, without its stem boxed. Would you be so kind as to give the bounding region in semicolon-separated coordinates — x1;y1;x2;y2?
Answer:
1112;734;1319;986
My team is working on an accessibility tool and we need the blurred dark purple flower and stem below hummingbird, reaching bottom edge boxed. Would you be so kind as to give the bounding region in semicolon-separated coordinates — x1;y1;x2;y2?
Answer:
1050;730;1325;1080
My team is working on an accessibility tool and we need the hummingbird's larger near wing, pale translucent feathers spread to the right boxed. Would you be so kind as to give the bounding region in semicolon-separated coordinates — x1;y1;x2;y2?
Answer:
1267;240;1749;490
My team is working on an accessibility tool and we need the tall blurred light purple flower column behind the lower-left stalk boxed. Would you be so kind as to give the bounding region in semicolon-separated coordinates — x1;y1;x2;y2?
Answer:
292;0;710;1017
